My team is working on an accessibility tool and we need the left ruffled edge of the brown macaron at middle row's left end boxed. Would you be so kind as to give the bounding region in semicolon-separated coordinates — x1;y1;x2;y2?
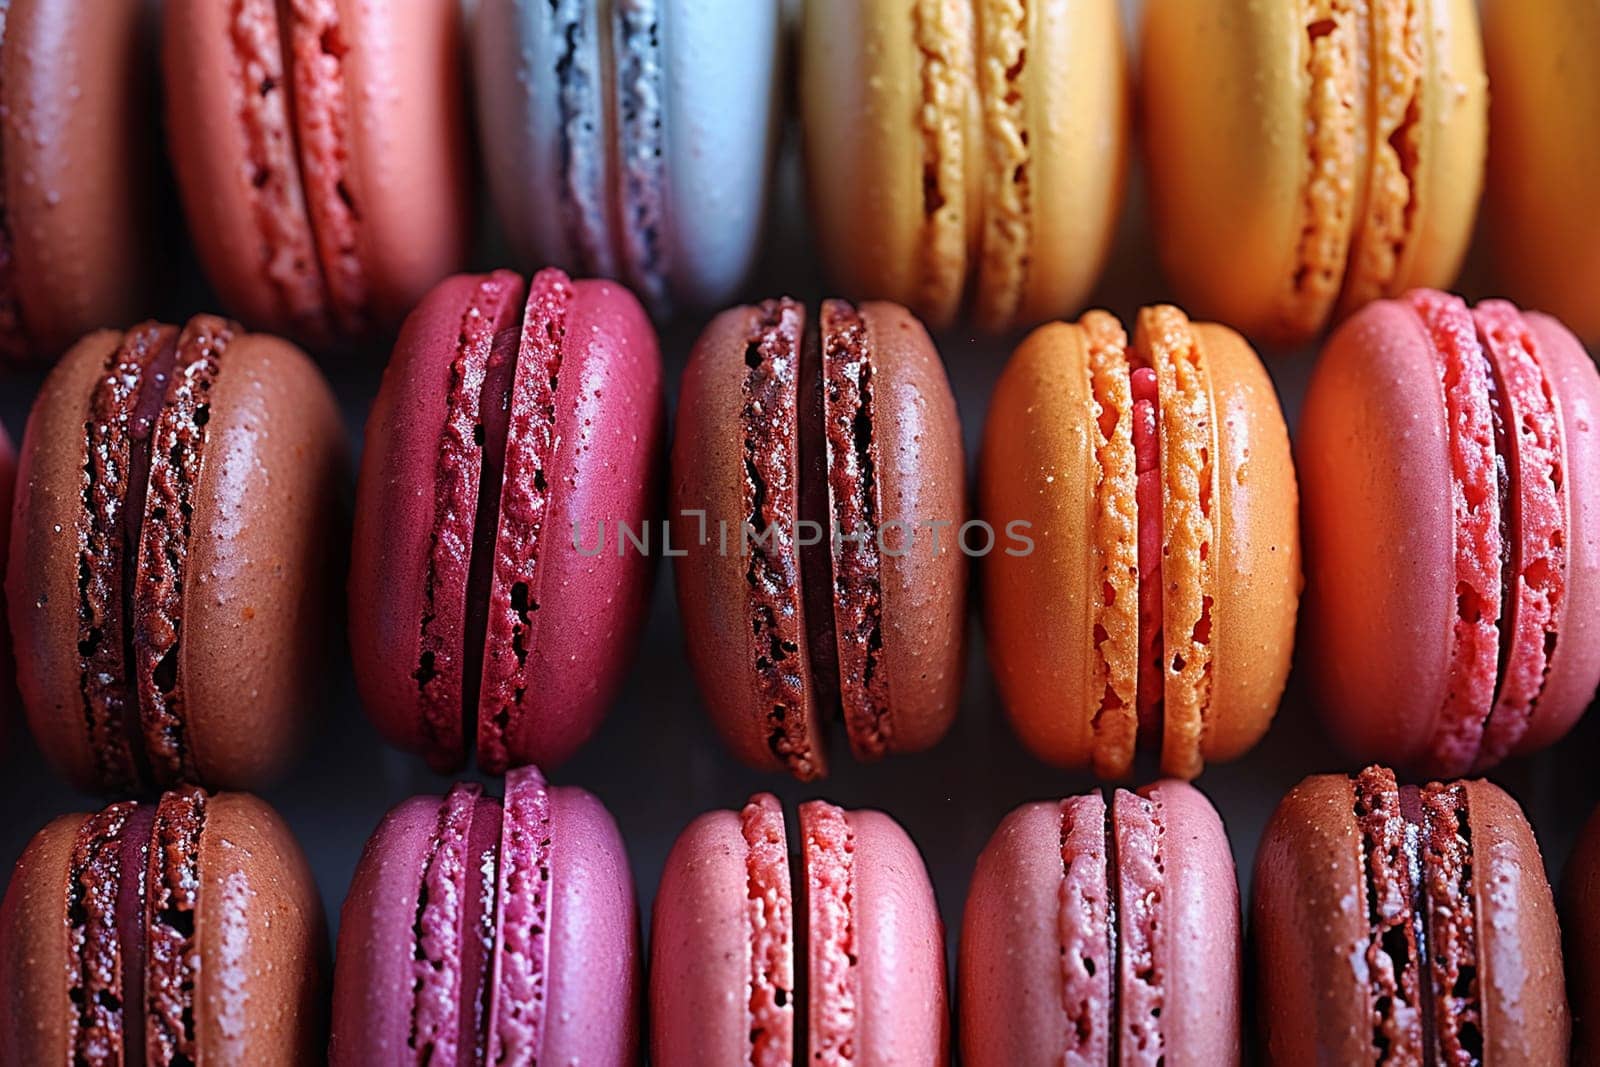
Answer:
77;323;178;793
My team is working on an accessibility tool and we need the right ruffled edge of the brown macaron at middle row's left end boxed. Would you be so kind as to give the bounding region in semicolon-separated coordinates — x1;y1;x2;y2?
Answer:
131;315;237;782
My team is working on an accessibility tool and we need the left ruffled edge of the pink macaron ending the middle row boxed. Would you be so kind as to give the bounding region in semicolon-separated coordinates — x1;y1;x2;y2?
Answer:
1408;291;1501;776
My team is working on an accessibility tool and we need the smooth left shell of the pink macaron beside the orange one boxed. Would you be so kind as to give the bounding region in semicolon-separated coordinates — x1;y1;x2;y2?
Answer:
1294;301;1456;765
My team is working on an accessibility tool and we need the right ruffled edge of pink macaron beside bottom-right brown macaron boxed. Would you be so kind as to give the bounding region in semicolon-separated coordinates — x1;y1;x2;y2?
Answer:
1112;790;1166;1067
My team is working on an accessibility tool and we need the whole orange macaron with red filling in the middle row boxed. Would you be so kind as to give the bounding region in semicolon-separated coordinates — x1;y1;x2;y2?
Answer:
978;306;1299;779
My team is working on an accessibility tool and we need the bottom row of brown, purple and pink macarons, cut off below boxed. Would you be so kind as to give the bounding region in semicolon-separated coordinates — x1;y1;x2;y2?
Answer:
0;765;1600;1067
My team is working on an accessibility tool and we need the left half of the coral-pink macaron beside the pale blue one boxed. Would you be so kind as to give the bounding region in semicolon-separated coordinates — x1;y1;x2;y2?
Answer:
162;0;330;338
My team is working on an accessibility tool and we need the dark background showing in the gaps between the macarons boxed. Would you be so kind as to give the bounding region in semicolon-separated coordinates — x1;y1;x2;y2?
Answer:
0;0;1600;991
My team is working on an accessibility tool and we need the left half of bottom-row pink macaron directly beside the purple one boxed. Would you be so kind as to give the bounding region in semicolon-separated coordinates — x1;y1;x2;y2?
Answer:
650;797;803;1067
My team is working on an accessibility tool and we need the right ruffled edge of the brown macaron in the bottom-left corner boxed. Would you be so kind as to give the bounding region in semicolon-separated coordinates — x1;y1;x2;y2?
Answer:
144;785;206;1067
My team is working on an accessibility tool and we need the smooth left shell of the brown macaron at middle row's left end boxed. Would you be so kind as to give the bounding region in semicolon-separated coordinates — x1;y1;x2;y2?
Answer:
6;331;122;792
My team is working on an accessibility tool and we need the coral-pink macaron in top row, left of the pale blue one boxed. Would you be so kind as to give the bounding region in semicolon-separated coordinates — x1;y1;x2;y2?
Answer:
162;0;472;346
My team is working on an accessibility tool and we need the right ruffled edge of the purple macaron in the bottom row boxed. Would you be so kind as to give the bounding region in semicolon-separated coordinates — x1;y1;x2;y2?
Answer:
482;766;552;1064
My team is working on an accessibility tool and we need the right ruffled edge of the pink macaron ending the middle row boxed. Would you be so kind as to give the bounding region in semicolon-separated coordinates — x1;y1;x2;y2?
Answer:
1472;301;1566;769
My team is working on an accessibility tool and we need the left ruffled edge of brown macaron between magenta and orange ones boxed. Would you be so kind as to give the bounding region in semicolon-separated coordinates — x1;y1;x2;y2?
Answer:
733;298;821;779
